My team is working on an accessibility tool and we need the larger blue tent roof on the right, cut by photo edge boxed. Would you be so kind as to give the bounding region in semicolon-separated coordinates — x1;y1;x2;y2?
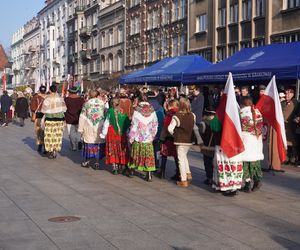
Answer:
183;42;300;84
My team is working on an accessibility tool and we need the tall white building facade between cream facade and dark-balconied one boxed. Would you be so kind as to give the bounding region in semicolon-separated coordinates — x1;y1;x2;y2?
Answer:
38;0;68;85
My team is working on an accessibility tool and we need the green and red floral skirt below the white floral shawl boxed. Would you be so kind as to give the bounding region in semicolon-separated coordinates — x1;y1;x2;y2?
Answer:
128;141;156;172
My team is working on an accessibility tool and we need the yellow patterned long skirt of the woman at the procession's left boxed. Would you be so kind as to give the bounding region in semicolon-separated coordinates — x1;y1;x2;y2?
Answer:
44;121;64;152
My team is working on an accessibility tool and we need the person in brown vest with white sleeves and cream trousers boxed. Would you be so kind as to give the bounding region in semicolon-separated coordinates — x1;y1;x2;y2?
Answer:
168;97;196;187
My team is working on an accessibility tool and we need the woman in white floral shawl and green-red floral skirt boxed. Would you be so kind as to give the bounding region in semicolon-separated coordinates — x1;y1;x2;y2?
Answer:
128;95;158;181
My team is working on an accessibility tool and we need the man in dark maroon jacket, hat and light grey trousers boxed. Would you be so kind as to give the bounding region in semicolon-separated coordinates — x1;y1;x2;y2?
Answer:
65;87;84;151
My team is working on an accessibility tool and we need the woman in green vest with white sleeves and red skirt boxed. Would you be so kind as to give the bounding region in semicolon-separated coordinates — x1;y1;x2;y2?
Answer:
100;98;130;175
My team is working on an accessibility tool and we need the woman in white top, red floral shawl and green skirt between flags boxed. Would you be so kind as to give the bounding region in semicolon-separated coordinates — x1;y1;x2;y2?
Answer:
240;97;264;192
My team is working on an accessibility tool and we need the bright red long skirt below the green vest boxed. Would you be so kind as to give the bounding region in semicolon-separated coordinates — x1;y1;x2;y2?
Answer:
105;125;129;165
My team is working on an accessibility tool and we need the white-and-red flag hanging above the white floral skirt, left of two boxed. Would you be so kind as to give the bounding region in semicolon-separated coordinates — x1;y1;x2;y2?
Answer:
216;73;245;158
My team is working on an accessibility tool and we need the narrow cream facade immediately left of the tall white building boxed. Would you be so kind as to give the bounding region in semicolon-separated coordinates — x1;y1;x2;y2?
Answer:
23;17;40;89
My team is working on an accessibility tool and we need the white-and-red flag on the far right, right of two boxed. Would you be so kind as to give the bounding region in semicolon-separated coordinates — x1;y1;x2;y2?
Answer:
256;76;287;162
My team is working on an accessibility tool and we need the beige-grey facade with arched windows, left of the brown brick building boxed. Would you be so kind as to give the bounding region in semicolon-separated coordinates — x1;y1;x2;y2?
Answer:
98;0;125;83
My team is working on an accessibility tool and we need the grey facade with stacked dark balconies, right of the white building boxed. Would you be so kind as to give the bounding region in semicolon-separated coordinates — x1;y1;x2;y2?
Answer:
67;0;100;85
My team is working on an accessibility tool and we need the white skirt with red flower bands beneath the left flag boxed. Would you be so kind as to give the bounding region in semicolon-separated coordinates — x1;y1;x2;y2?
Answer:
213;146;243;191
